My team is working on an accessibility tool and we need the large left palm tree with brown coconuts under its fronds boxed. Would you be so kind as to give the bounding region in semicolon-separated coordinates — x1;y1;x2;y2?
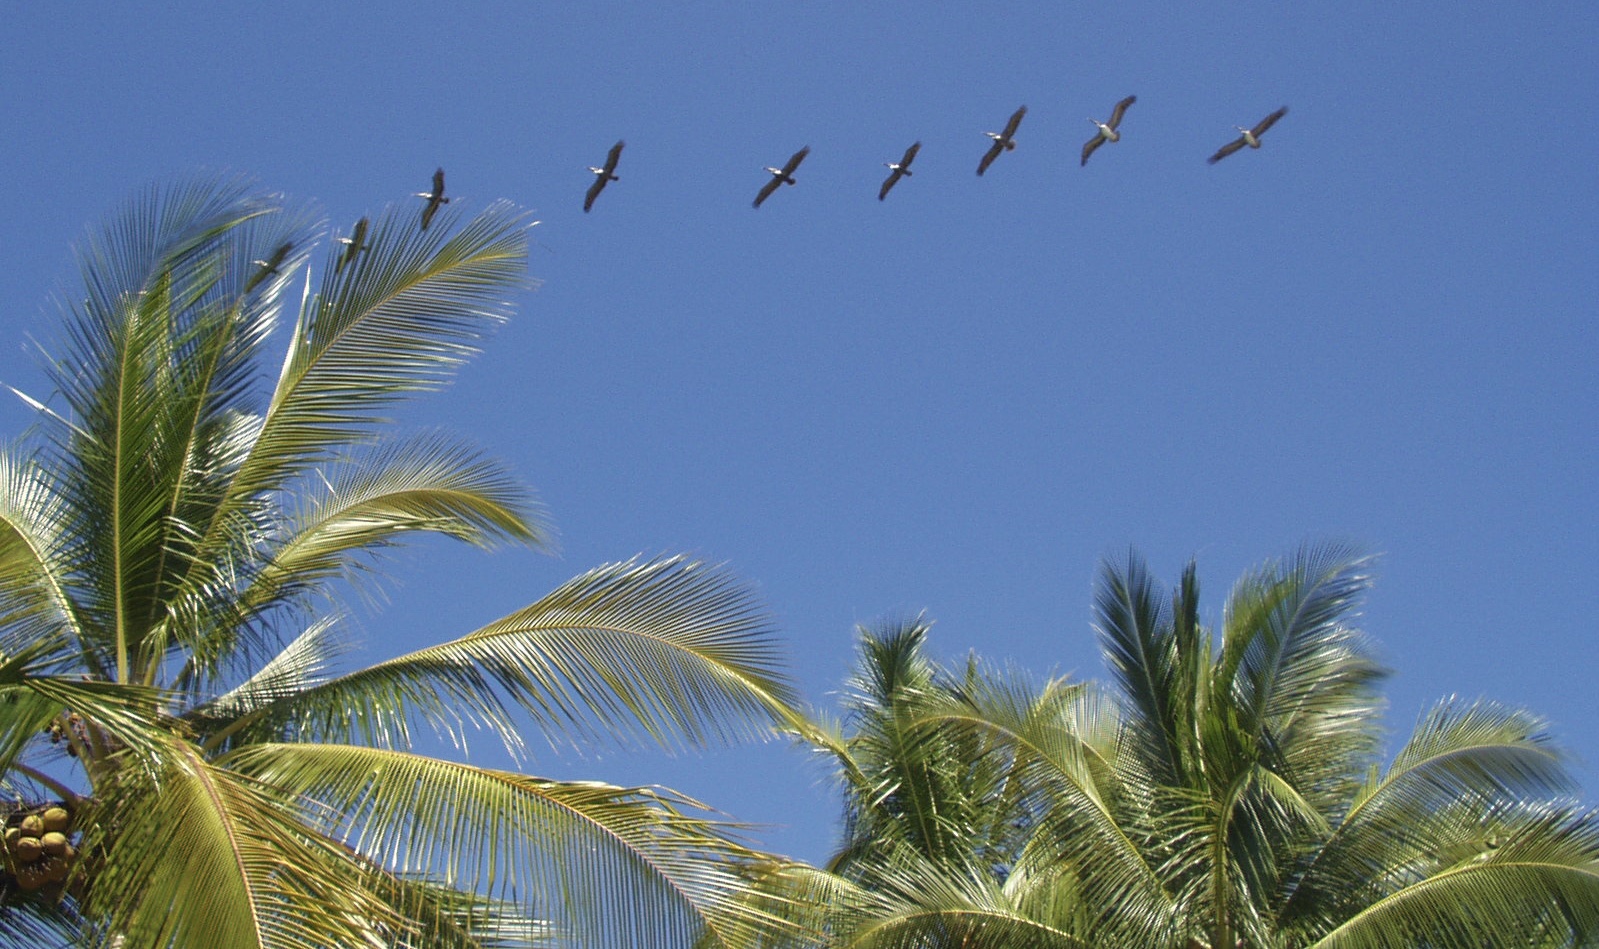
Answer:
0;181;792;949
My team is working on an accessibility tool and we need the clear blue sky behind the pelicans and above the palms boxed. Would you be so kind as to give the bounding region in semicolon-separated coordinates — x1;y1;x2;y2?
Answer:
0;0;1599;859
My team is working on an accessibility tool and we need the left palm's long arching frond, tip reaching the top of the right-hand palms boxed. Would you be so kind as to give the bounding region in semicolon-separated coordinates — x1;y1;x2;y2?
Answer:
244;557;793;749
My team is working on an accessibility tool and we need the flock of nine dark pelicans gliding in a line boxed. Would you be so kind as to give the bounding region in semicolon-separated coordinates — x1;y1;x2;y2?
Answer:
245;103;1289;281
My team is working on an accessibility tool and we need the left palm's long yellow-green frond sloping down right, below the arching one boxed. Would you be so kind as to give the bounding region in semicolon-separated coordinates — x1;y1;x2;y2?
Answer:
222;744;805;946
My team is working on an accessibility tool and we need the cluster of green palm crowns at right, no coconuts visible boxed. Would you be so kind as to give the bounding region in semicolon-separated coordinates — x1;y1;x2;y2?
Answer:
796;547;1599;949
